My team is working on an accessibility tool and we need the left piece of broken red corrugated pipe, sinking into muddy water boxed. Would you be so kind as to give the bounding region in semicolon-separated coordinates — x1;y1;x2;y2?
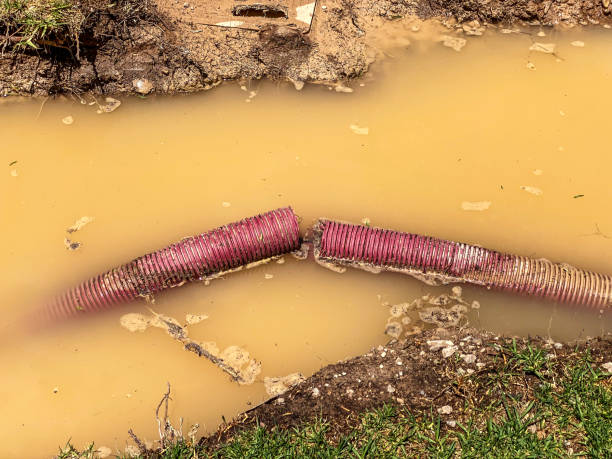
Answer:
45;207;300;319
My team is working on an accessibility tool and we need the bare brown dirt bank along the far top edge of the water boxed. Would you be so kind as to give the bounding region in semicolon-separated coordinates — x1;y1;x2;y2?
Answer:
0;0;612;96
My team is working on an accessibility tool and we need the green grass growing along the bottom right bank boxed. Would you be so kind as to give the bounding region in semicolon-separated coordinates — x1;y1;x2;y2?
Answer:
55;342;612;459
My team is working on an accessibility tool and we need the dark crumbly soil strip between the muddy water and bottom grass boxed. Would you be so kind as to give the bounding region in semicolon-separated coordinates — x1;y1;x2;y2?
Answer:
200;329;612;450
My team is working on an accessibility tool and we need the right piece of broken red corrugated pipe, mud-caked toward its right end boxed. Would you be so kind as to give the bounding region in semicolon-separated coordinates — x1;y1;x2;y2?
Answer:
314;219;612;309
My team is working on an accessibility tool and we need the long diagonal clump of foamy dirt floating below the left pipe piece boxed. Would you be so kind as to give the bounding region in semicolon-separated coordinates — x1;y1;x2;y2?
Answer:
119;311;261;385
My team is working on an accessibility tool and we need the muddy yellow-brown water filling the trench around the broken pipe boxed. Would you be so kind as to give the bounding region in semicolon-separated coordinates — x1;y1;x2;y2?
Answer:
0;30;612;457
